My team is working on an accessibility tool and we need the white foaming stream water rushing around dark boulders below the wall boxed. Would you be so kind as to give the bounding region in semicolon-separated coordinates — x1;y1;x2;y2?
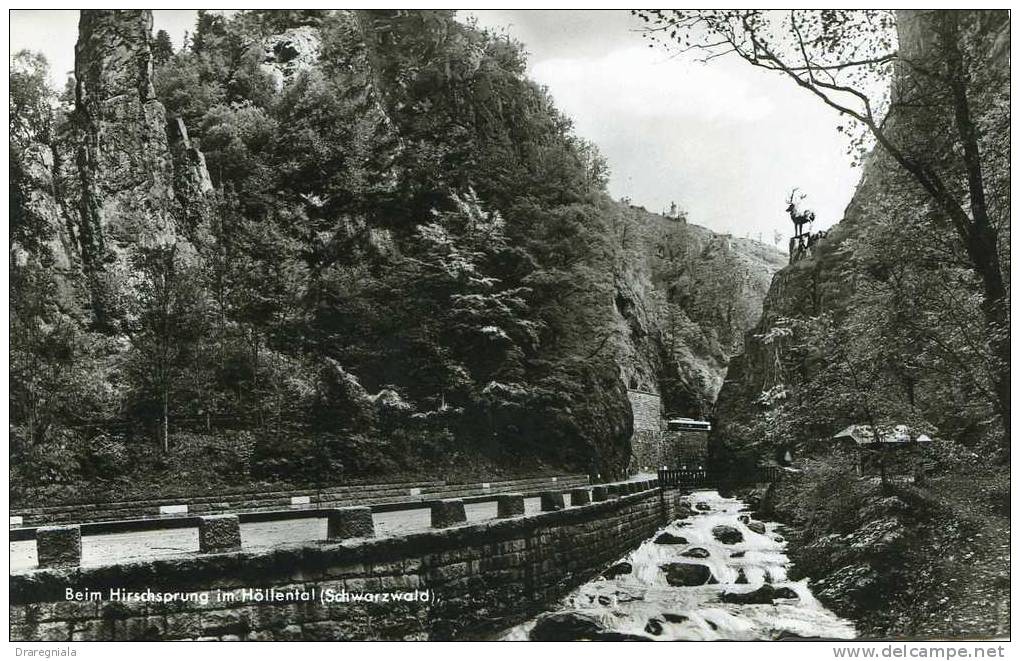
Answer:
502;491;856;641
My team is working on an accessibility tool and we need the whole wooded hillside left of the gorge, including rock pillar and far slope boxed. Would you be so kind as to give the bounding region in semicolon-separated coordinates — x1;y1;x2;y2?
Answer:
10;10;781;501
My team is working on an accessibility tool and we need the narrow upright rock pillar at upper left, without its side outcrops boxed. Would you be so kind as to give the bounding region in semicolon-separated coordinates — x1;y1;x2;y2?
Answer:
74;10;180;269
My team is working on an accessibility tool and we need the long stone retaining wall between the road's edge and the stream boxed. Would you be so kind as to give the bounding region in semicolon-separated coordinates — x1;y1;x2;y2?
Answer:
10;489;679;641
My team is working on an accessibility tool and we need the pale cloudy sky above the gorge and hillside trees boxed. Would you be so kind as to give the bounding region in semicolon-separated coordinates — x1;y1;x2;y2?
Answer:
11;10;860;242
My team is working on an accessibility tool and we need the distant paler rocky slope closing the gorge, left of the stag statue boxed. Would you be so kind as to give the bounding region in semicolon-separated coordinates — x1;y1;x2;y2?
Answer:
612;207;786;416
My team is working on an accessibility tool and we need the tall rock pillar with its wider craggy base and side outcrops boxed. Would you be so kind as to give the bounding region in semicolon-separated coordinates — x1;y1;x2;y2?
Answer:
26;10;212;321
